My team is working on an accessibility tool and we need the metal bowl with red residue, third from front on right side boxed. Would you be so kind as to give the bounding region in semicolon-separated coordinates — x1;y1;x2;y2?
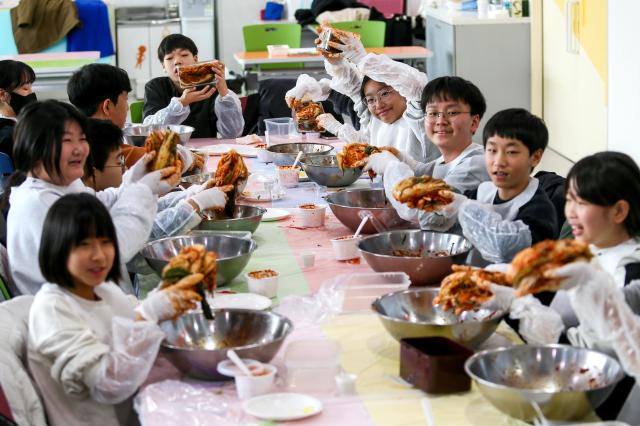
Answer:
358;229;471;286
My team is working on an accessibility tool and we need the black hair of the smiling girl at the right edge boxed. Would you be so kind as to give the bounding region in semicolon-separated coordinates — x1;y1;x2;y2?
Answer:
565;151;640;237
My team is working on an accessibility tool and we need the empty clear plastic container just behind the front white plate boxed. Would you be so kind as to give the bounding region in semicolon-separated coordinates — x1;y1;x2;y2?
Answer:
284;340;340;394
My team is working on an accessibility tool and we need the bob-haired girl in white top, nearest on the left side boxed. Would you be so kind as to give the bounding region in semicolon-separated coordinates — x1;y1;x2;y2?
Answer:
27;193;200;426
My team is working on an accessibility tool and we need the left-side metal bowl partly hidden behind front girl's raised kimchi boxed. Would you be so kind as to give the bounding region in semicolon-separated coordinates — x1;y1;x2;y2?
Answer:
140;234;258;285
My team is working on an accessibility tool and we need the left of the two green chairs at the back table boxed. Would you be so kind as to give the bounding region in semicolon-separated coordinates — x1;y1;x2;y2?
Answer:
242;23;304;70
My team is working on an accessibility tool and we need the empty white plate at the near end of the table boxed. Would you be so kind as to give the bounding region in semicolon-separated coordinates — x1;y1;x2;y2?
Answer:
242;393;322;421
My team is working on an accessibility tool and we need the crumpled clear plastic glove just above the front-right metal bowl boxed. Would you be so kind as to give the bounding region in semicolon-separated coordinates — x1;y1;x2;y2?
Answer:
509;294;564;345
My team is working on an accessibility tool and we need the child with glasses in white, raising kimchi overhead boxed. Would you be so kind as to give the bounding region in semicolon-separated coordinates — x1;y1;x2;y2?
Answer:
286;36;440;162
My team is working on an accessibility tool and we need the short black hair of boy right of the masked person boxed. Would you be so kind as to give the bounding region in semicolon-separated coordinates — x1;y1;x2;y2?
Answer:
67;64;131;117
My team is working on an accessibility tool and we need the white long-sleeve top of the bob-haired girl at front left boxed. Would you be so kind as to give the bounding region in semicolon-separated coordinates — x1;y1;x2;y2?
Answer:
27;282;164;426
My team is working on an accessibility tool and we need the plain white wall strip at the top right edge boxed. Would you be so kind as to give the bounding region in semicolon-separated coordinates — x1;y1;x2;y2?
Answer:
608;0;640;163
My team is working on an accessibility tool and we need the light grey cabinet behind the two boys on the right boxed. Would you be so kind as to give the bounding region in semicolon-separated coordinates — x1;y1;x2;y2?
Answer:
425;8;531;143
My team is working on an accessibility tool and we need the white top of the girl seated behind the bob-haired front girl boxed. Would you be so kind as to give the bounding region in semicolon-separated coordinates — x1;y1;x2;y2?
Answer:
7;177;157;294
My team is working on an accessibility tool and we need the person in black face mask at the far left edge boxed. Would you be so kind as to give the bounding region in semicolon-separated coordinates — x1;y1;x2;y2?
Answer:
0;59;37;158
